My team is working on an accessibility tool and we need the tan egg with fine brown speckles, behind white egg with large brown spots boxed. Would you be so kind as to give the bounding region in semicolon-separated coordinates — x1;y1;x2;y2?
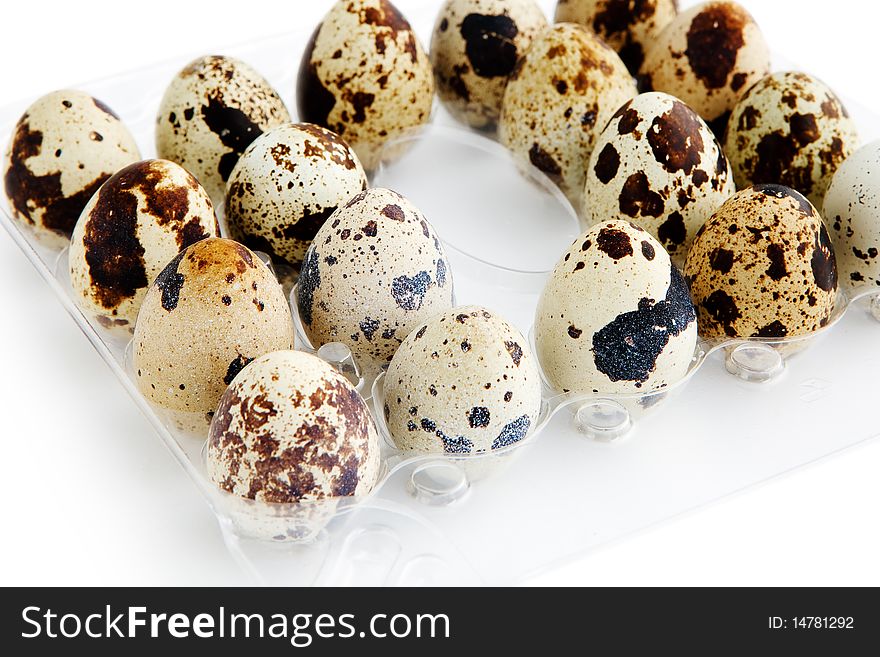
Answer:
498;23;636;208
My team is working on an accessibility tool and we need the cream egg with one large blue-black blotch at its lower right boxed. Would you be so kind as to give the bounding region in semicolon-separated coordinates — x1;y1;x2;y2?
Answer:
534;220;697;394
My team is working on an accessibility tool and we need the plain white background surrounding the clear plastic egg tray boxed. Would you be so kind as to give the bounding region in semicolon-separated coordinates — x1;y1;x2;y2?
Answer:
0;0;880;586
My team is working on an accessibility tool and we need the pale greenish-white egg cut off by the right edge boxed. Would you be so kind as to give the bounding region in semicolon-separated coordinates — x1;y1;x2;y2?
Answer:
822;141;880;289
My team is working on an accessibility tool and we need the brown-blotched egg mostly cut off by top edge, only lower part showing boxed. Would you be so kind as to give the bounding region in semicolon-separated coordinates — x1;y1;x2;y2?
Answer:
556;0;678;75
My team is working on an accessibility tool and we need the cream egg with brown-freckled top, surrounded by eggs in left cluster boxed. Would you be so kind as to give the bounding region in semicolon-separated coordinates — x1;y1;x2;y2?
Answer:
226;123;367;269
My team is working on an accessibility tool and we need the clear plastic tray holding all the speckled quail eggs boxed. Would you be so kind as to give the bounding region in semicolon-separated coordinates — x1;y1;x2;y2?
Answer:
0;11;880;585
